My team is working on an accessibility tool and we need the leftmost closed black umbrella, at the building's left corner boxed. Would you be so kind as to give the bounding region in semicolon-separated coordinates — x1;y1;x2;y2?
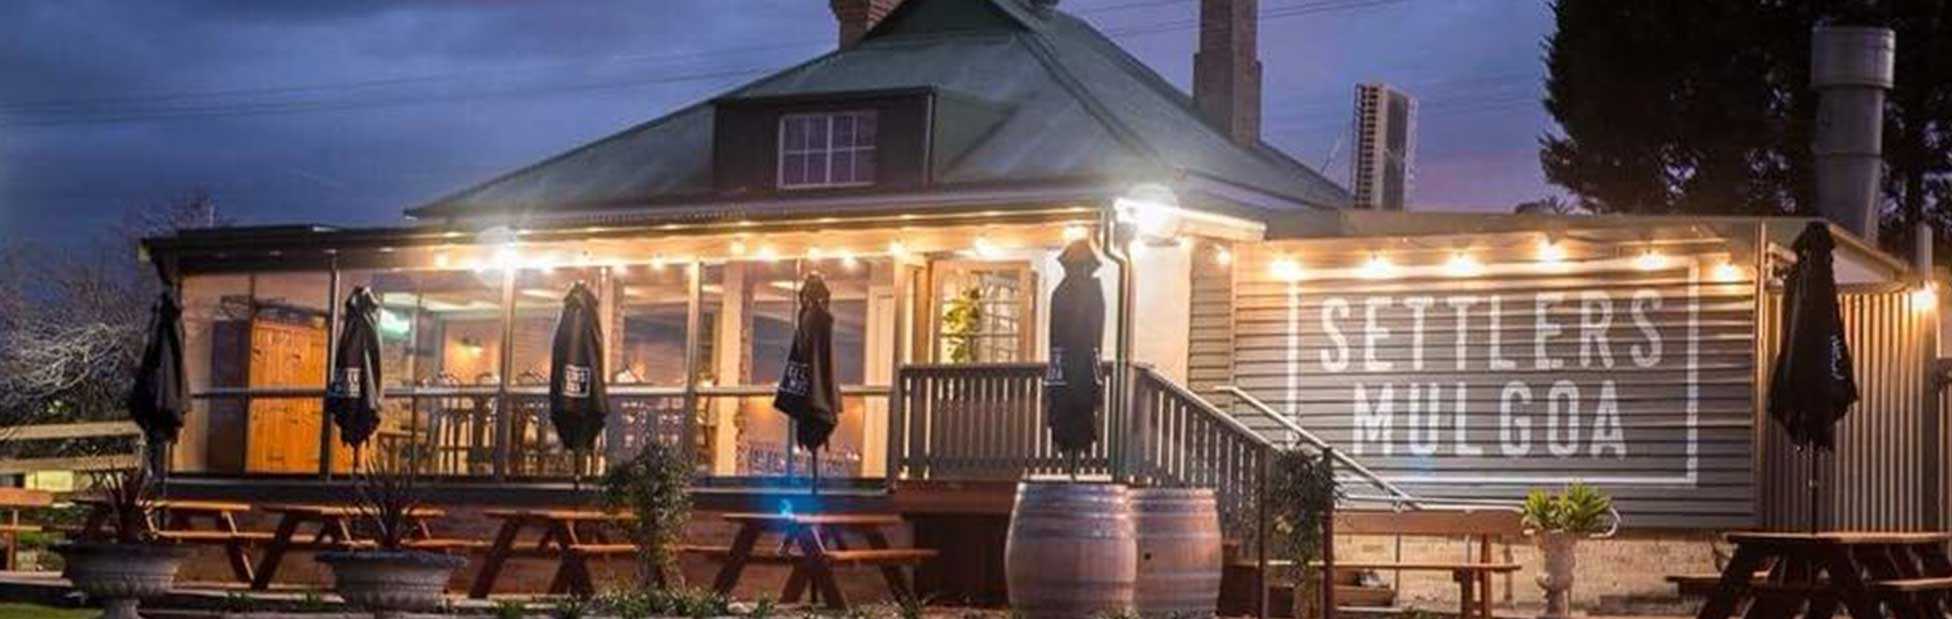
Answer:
129;291;189;473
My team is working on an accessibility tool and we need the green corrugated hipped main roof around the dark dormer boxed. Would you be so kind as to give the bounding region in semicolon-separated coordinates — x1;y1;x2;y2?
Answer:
410;0;1349;217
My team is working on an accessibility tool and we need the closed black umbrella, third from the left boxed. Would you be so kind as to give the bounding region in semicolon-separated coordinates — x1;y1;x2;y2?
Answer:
549;281;609;453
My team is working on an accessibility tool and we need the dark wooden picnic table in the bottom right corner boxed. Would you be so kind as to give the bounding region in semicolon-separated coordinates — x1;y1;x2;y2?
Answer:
1696;531;1952;619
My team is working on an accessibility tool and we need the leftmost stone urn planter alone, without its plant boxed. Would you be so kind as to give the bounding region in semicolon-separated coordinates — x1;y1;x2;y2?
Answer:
53;541;189;619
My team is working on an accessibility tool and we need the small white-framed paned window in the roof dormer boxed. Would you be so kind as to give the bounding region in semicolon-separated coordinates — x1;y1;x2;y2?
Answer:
779;111;874;189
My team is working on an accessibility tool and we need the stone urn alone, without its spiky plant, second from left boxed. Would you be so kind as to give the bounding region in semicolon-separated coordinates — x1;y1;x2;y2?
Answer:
318;551;468;617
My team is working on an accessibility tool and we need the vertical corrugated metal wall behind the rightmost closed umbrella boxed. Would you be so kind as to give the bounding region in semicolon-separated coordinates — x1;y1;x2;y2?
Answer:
1759;289;1952;531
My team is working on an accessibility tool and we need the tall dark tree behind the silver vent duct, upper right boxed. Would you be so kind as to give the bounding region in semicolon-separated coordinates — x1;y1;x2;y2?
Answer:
1540;0;1952;247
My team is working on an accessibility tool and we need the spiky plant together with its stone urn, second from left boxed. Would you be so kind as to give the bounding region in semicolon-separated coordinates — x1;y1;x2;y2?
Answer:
318;457;467;617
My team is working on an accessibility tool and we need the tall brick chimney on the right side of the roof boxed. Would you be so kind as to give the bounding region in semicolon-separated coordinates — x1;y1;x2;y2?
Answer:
1193;0;1261;146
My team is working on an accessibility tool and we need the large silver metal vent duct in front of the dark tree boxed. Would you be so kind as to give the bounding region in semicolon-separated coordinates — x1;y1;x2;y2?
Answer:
1810;25;1897;244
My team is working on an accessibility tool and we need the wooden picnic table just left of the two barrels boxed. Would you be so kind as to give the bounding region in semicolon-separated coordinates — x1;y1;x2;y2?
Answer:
706;514;935;609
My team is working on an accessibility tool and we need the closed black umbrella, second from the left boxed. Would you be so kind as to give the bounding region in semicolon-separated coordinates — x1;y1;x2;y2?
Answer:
326;285;386;454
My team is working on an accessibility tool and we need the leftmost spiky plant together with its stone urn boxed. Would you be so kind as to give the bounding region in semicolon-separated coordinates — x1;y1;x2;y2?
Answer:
55;467;187;619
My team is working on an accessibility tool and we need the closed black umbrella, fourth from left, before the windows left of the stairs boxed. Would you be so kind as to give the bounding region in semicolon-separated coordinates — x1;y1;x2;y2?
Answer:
773;273;841;492
